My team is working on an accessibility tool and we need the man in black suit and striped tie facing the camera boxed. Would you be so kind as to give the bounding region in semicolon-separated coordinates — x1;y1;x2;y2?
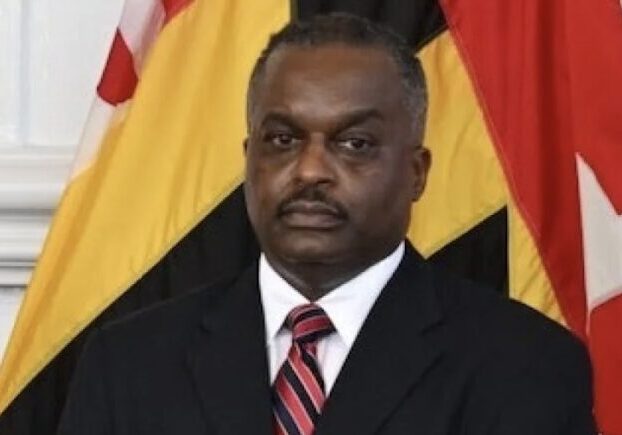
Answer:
60;15;594;435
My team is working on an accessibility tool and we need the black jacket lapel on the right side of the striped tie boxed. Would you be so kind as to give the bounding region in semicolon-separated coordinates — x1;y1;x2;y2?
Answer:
316;246;441;435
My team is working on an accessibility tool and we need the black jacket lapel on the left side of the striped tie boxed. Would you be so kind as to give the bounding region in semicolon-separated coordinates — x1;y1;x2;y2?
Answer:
188;267;272;435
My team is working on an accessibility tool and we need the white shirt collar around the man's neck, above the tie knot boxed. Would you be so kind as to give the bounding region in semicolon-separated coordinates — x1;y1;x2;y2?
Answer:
259;242;404;347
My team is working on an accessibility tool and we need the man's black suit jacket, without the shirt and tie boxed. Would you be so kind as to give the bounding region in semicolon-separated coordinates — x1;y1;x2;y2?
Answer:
59;247;595;435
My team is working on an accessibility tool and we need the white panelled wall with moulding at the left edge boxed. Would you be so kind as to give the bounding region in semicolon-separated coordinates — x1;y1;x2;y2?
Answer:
0;0;123;355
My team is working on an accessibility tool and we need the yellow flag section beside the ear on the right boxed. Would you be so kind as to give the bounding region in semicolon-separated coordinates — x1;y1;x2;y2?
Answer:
408;32;507;257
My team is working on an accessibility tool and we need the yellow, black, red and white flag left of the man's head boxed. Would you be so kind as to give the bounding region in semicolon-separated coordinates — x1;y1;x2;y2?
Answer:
0;0;289;434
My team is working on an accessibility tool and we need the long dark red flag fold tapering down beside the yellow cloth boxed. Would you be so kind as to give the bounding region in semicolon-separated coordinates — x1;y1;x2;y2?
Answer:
442;0;587;337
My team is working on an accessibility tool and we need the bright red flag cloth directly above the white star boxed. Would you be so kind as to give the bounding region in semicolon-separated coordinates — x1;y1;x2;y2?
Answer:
567;0;622;215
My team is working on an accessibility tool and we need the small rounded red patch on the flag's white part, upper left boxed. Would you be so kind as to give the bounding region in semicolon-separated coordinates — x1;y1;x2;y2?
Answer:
97;30;138;105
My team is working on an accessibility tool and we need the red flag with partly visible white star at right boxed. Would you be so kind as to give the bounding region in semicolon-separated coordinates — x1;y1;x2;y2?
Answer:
442;0;622;434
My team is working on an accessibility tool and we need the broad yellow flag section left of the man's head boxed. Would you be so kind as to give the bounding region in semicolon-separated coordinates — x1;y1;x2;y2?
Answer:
0;0;289;410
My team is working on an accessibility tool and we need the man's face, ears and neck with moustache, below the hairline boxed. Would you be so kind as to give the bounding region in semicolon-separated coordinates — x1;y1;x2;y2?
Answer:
245;44;430;301
